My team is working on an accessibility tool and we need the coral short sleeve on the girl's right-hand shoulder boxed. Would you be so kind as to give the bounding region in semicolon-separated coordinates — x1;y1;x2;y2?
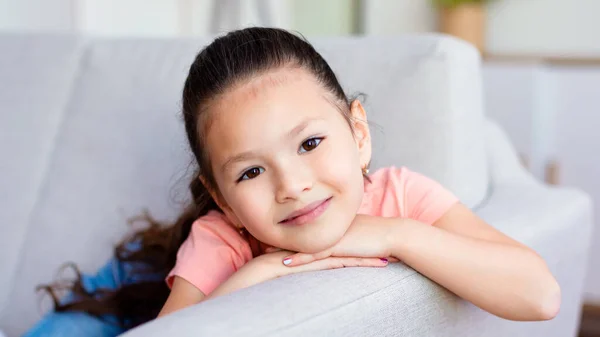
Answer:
400;168;459;225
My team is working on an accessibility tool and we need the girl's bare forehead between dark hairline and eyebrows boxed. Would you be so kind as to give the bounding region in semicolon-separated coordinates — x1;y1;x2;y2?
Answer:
207;68;343;161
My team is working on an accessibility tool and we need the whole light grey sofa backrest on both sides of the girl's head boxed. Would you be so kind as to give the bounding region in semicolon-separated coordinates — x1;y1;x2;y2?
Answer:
0;35;488;334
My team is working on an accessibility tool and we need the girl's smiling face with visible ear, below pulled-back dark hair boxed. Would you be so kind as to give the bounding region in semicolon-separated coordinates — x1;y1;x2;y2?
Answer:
206;68;371;253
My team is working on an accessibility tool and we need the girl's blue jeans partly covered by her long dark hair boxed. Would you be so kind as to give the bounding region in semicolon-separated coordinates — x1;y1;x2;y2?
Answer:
24;242;162;337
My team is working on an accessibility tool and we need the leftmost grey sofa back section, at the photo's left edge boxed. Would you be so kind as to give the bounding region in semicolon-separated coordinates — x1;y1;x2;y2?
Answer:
0;35;83;317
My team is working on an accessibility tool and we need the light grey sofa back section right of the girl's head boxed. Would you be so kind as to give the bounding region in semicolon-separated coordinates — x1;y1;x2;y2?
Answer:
315;34;488;207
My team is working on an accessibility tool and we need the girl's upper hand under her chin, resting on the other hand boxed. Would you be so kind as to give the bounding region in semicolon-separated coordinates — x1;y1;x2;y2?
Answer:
282;214;398;268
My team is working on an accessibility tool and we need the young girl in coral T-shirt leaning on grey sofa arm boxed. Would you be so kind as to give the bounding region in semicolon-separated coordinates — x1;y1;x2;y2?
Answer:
27;28;560;335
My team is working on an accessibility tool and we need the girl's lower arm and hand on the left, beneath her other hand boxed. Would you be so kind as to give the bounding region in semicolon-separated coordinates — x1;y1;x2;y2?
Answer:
158;251;387;317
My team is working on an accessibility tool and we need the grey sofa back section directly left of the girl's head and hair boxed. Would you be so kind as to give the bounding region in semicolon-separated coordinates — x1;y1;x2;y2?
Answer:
2;40;211;335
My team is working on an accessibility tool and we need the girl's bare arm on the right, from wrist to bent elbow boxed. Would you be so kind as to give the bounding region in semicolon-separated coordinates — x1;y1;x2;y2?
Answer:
389;219;560;321
